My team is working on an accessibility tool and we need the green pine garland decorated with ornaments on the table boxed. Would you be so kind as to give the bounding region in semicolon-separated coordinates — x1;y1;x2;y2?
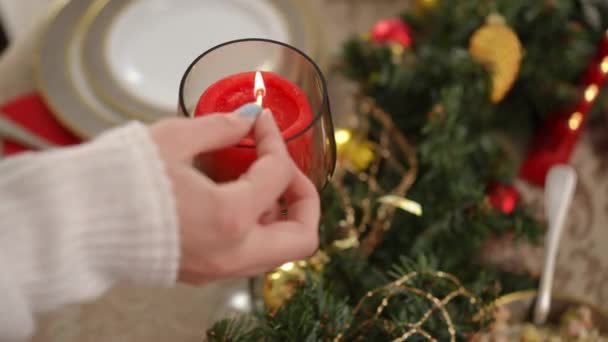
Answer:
208;0;608;341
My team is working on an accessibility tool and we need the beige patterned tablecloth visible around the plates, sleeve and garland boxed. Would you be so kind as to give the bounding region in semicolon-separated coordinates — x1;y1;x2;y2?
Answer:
0;0;608;342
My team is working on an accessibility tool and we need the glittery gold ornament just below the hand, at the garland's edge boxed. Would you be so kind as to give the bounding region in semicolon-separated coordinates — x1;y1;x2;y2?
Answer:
262;251;329;314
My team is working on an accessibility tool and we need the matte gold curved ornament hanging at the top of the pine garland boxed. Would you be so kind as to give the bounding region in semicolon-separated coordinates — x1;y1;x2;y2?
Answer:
469;14;523;103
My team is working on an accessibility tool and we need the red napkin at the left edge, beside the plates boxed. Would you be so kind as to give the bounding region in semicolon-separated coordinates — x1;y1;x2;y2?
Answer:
0;93;81;155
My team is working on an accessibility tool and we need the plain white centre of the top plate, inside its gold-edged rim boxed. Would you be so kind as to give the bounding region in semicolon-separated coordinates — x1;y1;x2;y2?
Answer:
106;0;290;111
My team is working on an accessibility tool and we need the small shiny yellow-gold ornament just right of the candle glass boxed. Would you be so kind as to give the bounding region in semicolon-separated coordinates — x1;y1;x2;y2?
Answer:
335;129;376;171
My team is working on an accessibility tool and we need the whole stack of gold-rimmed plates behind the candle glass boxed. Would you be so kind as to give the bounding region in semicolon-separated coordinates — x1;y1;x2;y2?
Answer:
36;0;321;139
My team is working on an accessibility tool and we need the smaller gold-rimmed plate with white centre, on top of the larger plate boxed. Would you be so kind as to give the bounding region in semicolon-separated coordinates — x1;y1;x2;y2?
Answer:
79;0;315;120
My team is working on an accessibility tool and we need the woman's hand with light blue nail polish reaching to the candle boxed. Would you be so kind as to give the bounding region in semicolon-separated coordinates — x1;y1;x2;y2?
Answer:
151;105;320;284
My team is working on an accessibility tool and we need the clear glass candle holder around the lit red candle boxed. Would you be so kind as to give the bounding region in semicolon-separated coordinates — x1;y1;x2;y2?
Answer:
178;38;336;191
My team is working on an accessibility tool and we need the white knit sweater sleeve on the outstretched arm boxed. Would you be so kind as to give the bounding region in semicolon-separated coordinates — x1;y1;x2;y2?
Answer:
0;123;179;341
